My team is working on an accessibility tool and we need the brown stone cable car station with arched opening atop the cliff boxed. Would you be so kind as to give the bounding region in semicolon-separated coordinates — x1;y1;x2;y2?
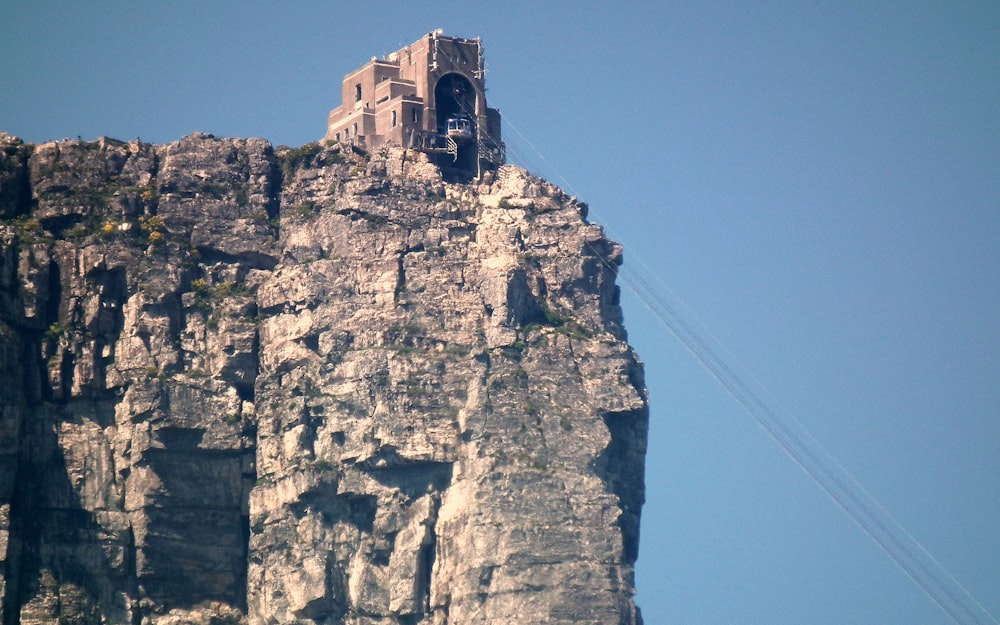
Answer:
324;29;505;176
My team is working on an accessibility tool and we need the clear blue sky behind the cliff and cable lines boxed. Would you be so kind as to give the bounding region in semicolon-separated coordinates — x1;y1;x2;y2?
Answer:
0;0;1000;625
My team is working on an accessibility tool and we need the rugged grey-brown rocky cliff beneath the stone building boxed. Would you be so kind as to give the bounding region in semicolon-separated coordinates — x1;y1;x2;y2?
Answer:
0;134;648;625
